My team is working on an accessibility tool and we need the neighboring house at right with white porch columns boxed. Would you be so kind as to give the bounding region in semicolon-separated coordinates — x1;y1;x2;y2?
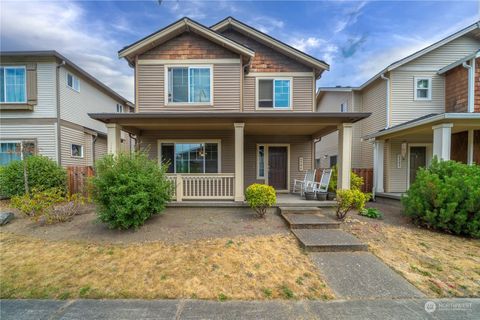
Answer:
316;23;480;193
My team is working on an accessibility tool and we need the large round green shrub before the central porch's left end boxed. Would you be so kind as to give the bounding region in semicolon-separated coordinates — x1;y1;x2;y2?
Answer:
91;152;173;229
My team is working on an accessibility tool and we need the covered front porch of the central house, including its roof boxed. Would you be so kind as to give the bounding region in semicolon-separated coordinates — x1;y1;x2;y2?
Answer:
91;112;369;202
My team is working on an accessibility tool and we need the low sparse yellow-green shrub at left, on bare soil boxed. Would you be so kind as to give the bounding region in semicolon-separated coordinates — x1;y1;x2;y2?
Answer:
10;188;86;224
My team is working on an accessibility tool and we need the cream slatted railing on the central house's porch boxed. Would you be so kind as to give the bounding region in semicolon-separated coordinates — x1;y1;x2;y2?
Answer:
168;173;235;201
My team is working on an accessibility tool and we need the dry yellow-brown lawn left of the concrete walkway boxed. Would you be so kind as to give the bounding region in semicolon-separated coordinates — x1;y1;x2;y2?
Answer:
0;232;333;300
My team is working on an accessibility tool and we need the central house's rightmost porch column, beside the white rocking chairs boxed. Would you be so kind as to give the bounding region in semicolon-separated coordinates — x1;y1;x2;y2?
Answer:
337;123;353;189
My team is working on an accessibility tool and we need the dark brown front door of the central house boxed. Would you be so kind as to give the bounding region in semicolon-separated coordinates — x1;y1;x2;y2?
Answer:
268;147;288;190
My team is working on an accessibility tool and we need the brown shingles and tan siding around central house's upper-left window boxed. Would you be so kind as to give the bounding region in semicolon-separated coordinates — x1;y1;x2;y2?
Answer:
137;33;241;112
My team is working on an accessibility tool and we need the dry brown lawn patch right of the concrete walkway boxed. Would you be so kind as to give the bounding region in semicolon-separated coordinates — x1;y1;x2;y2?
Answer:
344;219;480;297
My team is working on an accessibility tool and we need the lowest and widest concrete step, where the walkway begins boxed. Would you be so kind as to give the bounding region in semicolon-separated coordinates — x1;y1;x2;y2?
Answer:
292;229;368;252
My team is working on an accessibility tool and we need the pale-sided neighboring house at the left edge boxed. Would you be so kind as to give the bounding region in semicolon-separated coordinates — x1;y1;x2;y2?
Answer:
0;51;134;166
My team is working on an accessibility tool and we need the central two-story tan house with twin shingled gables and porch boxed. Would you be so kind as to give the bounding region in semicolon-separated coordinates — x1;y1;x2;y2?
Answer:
91;17;368;201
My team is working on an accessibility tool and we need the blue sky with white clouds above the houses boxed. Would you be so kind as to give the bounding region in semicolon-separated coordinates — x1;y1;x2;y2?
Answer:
0;0;479;99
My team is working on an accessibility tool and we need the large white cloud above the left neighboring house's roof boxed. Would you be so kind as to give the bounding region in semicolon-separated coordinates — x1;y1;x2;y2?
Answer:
0;1;133;100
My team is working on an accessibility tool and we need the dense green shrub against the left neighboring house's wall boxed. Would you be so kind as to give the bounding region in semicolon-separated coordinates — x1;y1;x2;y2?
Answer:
0;156;67;197
